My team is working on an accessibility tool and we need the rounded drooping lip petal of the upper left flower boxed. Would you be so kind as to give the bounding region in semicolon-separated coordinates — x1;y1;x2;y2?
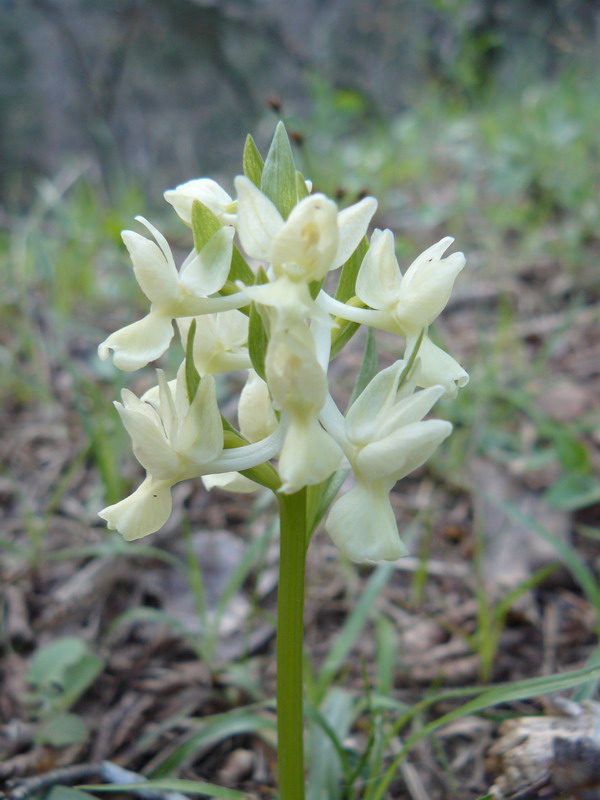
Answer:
98;310;173;372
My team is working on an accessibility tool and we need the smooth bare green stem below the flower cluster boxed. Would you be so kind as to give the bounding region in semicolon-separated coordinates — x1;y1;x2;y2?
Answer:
277;489;306;800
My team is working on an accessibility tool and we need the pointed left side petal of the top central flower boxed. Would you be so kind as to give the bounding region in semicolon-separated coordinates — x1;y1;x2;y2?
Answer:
235;175;283;261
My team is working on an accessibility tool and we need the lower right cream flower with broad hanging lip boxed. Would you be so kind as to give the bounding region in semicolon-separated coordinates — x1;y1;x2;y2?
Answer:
321;361;452;561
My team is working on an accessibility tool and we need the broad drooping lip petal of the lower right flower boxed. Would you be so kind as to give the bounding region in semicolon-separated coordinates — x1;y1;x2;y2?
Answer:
325;482;407;561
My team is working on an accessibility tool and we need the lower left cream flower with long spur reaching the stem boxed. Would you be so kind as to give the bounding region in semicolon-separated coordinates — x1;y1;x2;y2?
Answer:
100;362;281;540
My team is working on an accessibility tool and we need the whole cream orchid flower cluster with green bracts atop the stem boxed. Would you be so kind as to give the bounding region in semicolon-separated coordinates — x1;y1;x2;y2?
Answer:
99;124;468;561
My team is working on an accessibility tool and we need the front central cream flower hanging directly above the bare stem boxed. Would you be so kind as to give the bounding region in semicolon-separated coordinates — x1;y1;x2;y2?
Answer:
265;325;342;494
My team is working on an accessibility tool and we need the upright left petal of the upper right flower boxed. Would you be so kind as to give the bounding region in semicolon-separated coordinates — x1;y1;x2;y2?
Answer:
356;230;402;309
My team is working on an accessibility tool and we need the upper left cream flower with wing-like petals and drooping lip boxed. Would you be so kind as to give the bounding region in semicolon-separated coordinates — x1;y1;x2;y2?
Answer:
98;217;241;372
